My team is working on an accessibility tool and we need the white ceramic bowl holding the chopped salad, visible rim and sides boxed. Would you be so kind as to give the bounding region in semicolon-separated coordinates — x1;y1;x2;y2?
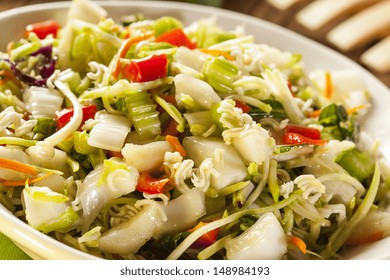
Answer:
0;1;390;259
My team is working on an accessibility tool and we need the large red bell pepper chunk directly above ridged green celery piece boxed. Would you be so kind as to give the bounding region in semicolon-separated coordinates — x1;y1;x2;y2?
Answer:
122;54;168;83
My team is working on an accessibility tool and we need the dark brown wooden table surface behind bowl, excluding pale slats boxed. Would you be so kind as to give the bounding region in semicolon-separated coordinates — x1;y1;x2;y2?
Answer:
0;0;390;87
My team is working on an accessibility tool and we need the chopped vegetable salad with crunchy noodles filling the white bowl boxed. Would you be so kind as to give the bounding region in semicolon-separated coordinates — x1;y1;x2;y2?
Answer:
0;0;390;260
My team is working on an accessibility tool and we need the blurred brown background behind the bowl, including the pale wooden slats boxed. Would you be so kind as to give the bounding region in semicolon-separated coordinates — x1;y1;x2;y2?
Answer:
0;0;390;87
